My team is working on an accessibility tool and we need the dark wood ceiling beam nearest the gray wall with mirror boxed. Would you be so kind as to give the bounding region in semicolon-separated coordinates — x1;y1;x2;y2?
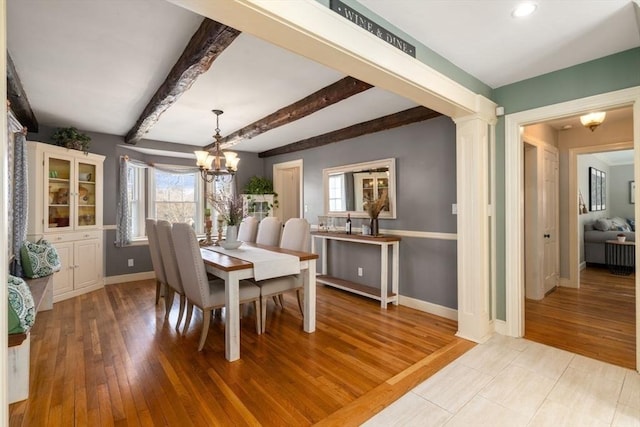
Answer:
258;107;442;157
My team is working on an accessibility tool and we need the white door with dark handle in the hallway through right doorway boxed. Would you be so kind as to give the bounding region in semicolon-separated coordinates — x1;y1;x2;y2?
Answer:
541;146;560;294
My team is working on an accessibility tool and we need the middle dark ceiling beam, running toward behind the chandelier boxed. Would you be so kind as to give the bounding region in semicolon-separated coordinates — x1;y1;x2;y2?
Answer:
205;77;372;150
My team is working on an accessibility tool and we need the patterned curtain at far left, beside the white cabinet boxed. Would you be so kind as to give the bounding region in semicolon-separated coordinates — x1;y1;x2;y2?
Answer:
11;132;29;277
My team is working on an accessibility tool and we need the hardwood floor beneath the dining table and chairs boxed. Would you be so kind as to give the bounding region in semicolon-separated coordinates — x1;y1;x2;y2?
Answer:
10;280;474;426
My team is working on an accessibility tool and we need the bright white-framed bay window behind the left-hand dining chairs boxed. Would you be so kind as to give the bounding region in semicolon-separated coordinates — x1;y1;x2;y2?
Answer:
127;163;204;239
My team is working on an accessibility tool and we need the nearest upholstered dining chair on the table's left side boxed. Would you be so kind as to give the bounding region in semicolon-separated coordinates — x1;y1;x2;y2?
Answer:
171;223;262;351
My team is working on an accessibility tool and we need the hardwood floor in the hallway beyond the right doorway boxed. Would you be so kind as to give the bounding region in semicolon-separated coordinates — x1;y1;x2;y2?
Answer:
525;267;636;369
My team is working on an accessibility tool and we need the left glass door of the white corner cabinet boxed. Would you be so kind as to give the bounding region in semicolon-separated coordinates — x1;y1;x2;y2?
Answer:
45;155;73;231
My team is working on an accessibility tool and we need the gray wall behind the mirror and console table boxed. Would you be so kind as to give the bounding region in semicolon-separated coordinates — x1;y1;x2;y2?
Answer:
265;117;457;309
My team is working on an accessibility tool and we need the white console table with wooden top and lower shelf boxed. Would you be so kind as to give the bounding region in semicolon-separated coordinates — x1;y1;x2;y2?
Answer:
311;231;400;309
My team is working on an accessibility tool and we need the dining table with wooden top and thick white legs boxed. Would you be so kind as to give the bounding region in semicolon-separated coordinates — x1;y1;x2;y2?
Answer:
200;243;318;362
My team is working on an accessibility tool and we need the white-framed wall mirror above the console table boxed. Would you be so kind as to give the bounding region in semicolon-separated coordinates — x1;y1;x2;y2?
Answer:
322;158;396;219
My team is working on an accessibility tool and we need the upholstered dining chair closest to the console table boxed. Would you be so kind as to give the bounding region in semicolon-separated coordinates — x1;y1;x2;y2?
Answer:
255;218;311;333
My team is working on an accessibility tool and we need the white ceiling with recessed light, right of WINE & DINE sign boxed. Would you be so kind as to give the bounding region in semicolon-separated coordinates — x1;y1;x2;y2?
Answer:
359;0;640;88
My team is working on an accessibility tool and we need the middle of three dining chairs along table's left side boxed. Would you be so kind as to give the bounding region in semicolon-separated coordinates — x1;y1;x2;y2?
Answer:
156;220;187;331
